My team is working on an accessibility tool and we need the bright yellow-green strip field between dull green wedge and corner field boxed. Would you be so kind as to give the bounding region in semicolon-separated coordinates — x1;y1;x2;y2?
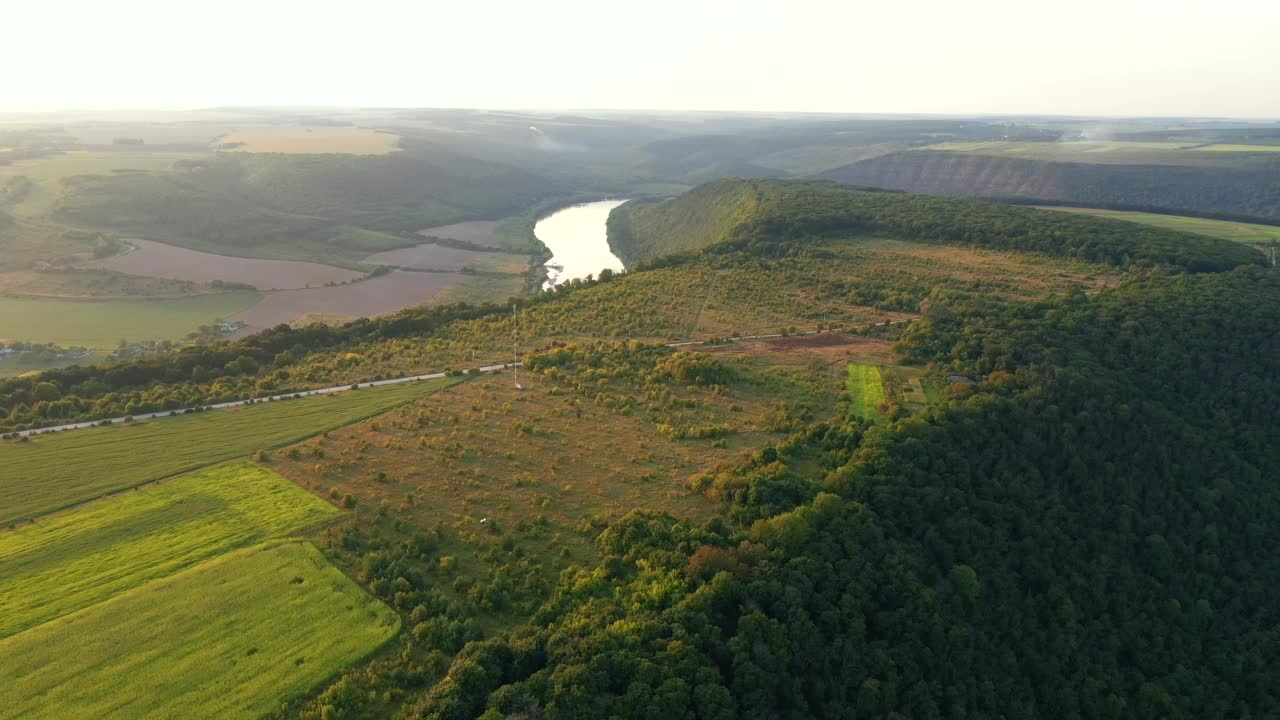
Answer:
0;462;340;637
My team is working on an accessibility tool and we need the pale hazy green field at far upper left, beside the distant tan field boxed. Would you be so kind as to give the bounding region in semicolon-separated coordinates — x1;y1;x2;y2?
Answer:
0;151;201;218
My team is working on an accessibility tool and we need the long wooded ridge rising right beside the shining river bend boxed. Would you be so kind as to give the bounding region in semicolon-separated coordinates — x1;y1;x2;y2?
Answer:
608;179;1262;272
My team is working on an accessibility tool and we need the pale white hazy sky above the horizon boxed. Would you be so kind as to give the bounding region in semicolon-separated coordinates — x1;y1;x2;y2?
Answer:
10;0;1280;118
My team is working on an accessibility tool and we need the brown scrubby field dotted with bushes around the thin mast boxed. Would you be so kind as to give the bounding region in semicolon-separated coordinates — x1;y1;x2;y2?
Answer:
273;353;803;574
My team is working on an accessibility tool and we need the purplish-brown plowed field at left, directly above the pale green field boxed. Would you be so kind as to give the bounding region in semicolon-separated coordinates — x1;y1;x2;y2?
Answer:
86;240;364;290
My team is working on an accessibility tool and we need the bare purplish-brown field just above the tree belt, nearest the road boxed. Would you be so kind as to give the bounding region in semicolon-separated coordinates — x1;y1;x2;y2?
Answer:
232;270;466;334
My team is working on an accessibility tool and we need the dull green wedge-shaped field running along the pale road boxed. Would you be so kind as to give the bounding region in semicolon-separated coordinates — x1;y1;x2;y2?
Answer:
0;378;458;523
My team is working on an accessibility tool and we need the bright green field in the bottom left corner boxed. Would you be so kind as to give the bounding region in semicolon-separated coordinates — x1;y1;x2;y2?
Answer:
0;542;399;720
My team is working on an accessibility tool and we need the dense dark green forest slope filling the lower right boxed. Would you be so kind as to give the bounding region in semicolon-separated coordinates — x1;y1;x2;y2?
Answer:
412;268;1280;719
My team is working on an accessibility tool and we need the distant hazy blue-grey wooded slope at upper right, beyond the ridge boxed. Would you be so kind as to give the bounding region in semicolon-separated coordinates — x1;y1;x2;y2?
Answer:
822;151;1280;220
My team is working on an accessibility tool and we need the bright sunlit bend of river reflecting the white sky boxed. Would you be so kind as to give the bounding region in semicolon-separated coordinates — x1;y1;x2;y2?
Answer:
534;200;626;287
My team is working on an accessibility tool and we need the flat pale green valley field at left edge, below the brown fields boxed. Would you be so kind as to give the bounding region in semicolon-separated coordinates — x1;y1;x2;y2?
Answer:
0;292;262;348
